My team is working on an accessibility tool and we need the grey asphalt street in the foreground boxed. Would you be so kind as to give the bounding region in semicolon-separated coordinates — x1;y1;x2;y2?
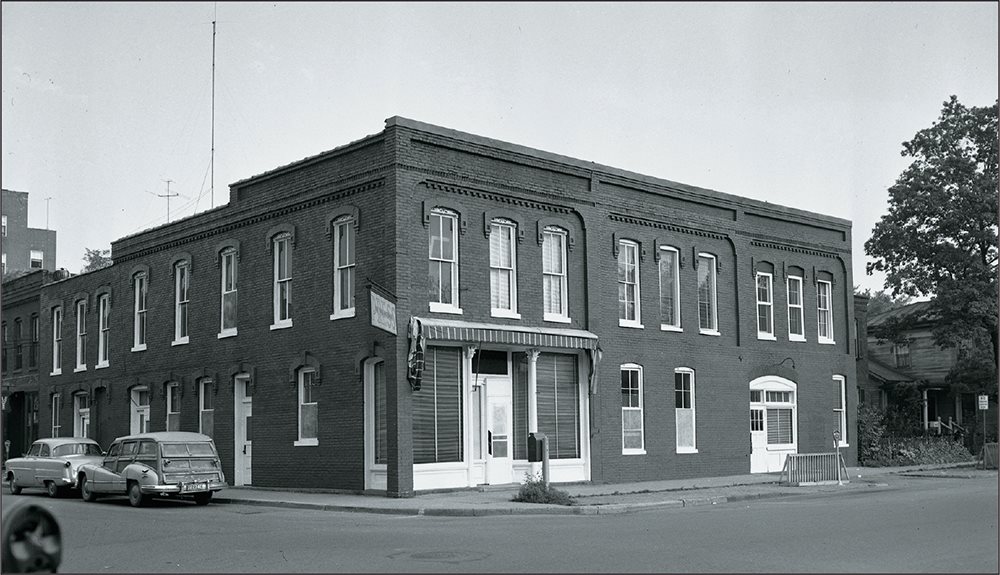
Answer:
3;475;998;573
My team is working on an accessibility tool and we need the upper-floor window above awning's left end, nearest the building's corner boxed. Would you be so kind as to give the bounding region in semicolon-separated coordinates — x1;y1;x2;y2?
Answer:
428;209;462;313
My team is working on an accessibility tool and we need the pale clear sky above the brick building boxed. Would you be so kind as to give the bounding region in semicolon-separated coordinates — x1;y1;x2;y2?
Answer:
0;2;998;291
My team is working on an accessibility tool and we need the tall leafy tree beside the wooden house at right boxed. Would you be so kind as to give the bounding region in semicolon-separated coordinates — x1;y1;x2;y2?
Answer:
865;96;1000;393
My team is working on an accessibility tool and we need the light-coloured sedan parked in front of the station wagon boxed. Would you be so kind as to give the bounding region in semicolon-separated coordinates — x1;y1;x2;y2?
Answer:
4;437;103;497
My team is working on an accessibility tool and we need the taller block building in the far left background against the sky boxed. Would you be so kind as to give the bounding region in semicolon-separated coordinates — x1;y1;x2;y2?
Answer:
0;190;56;277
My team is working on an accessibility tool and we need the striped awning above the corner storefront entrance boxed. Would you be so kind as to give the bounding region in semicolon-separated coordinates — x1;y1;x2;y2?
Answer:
413;317;597;349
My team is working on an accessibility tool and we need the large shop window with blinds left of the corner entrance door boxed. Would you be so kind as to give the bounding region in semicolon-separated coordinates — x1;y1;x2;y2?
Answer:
413;347;463;463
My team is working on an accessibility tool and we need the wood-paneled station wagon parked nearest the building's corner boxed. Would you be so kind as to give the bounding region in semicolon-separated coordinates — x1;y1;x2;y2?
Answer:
77;431;226;507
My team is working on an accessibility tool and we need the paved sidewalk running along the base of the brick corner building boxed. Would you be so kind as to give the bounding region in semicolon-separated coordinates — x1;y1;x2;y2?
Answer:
212;463;984;516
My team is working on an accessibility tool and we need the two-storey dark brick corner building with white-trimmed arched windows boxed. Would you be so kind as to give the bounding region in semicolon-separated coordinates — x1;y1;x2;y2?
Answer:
21;117;857;496
